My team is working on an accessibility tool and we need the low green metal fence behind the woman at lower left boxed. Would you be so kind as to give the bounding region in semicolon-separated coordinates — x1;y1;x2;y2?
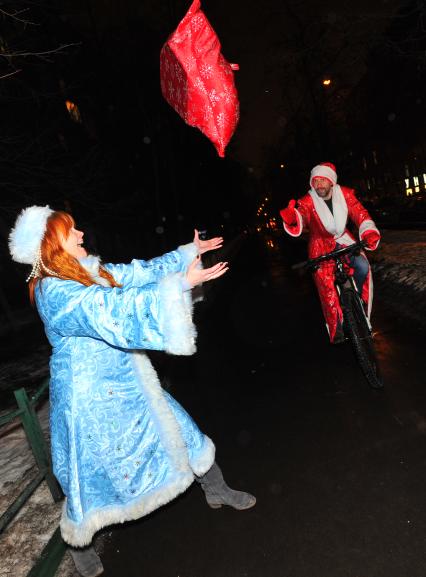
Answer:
0;379;66;577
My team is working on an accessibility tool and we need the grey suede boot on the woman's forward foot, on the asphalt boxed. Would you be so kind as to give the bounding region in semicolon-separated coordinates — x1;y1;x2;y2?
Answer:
196;462;256;511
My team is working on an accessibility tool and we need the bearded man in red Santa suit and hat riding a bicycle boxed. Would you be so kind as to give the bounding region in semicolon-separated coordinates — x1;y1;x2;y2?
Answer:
280;162;380;344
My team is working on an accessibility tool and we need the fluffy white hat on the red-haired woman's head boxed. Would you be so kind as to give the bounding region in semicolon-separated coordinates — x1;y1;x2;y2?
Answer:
9;205;54;265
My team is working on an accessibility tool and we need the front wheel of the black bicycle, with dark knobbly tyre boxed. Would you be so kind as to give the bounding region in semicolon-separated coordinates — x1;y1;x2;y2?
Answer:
342;289;383;389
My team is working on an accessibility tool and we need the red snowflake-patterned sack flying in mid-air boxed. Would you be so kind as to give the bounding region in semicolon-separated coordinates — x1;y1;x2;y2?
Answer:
160;0;239;156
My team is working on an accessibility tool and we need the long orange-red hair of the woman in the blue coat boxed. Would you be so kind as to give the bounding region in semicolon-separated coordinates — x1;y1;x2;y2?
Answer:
28;211;121;303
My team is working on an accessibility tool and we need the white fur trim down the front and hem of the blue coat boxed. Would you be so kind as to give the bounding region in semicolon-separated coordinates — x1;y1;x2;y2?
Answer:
60;352;215;547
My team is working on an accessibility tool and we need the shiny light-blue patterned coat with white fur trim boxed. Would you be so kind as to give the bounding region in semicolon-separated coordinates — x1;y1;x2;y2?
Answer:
36;244;214;547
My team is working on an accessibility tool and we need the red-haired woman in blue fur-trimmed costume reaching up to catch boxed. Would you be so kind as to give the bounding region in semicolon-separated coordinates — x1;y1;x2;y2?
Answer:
9;206;255;577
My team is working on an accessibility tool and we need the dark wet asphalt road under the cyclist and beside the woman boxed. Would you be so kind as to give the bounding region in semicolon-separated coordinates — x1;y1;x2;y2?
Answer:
97;233;426;577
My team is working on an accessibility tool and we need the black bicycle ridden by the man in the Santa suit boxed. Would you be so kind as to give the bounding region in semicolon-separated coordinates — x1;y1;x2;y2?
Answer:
292;242;384;389
